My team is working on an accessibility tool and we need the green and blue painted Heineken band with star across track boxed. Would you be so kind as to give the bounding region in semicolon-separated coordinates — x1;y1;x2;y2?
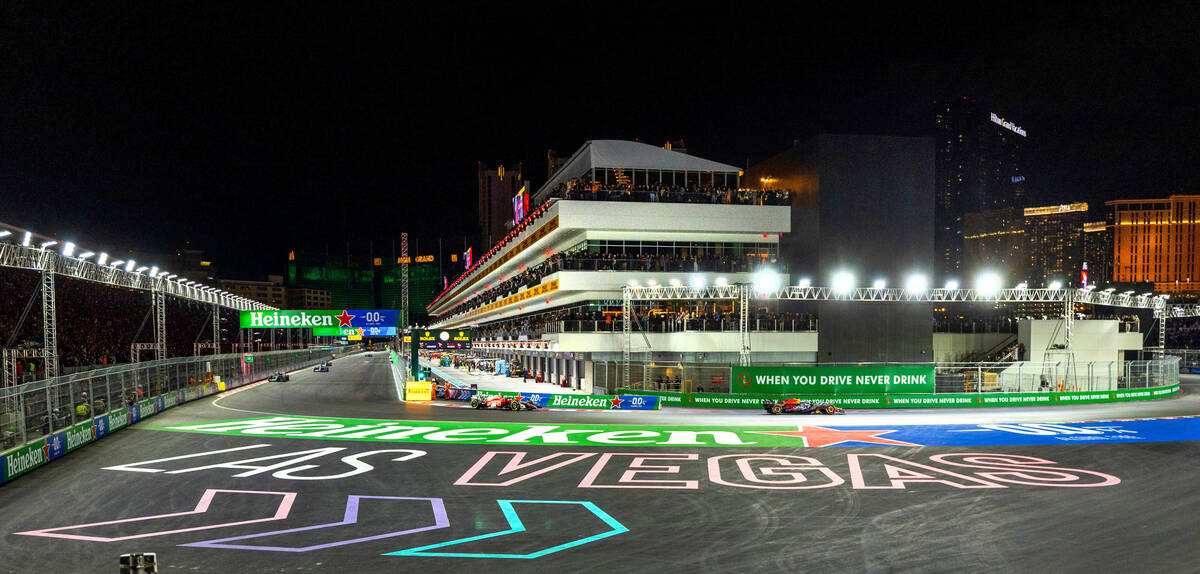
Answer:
152;417;1200;448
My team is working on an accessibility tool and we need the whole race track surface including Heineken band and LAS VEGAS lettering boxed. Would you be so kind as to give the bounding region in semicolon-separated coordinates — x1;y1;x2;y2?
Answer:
0;353;1200;573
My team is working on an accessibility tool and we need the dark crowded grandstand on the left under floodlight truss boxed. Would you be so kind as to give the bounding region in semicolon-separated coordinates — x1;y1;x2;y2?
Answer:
0;223;275;387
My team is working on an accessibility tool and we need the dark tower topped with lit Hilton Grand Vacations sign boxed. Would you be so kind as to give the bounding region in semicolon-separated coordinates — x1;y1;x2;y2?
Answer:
934;97;1030;279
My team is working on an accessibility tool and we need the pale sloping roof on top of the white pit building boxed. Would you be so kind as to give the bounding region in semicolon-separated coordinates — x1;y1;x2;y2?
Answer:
538;139;740;201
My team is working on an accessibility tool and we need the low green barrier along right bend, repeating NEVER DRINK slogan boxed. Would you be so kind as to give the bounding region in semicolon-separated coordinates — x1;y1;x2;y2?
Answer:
620;384;1180;408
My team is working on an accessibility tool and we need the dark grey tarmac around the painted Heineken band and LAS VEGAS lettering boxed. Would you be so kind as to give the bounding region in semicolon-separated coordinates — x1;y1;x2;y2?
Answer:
0;354;1200;573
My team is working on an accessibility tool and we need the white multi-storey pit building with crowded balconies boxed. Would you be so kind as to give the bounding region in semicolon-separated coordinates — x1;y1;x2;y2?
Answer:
427;140;817;391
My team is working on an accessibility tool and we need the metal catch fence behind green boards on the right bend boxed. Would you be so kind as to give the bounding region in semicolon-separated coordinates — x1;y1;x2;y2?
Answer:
593;352;1180;394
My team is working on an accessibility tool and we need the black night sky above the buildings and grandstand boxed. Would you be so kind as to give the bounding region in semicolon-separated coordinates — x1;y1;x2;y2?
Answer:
0;1;1200;279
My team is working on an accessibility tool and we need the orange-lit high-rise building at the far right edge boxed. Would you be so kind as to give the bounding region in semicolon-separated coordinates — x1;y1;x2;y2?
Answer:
1106;196;1200;292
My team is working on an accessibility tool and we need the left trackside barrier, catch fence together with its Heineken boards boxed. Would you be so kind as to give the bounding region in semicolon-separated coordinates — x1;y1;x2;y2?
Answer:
0;347;350;484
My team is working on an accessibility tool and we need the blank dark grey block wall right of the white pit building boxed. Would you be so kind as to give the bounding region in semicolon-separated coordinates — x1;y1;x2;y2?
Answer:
746;134;935;363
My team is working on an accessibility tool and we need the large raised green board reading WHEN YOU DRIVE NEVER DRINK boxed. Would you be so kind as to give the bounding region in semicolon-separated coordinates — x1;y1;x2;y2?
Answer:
733;366;935;395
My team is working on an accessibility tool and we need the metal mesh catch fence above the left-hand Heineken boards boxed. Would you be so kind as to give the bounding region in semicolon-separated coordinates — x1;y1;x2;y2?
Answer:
0;348;344;450
